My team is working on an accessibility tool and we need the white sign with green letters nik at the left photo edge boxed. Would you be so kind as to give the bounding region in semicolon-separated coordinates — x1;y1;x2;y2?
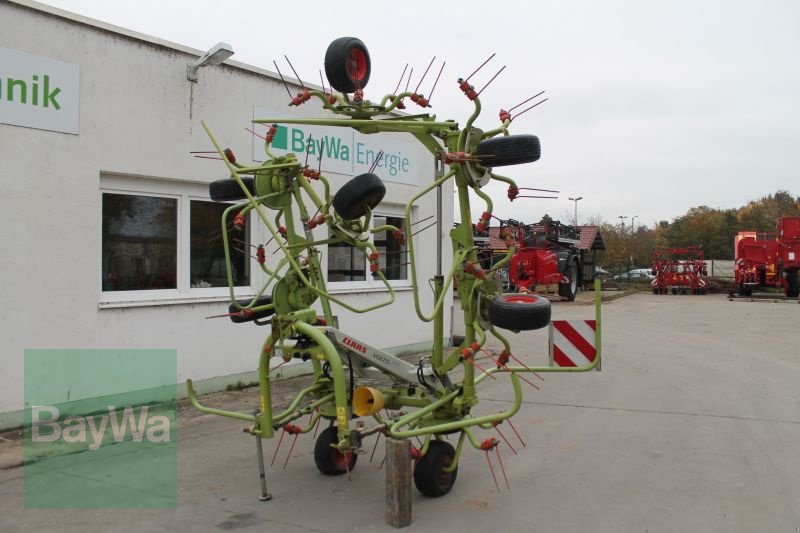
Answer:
0;47;80;134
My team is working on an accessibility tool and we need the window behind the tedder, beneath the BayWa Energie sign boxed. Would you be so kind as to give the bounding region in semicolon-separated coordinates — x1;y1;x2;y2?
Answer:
328;210;408;288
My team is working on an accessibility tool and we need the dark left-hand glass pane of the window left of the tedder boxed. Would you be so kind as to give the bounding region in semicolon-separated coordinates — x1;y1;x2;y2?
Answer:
102;194;178;291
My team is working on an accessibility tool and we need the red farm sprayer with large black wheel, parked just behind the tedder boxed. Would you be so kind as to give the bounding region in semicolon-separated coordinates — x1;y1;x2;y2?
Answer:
500;219;594;302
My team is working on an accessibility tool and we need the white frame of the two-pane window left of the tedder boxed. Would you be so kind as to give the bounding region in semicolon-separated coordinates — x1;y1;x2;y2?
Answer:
97;174;263;309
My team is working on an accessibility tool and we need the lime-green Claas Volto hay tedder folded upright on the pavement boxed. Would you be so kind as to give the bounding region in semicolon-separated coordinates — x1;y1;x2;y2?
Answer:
187;37;601;500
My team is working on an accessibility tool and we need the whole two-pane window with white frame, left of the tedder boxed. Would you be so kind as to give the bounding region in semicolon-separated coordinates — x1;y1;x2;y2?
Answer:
100;176;258;307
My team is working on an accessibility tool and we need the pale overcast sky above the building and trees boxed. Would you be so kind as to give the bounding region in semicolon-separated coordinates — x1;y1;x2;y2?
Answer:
34;0;800;227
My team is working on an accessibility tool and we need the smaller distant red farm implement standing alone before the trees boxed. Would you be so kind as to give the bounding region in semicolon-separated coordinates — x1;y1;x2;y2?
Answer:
650;246;708;294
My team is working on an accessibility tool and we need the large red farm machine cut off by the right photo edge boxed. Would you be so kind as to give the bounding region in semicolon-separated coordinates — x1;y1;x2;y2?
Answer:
734;217;800;298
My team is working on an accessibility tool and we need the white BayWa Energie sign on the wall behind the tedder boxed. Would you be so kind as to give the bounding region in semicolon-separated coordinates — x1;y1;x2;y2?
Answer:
253;107;422;185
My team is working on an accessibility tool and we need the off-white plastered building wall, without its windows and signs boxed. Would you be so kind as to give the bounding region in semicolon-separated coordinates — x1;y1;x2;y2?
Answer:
0;2;453;423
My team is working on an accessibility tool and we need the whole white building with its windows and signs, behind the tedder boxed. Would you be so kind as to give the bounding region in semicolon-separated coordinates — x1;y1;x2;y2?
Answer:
0;0;453;427
